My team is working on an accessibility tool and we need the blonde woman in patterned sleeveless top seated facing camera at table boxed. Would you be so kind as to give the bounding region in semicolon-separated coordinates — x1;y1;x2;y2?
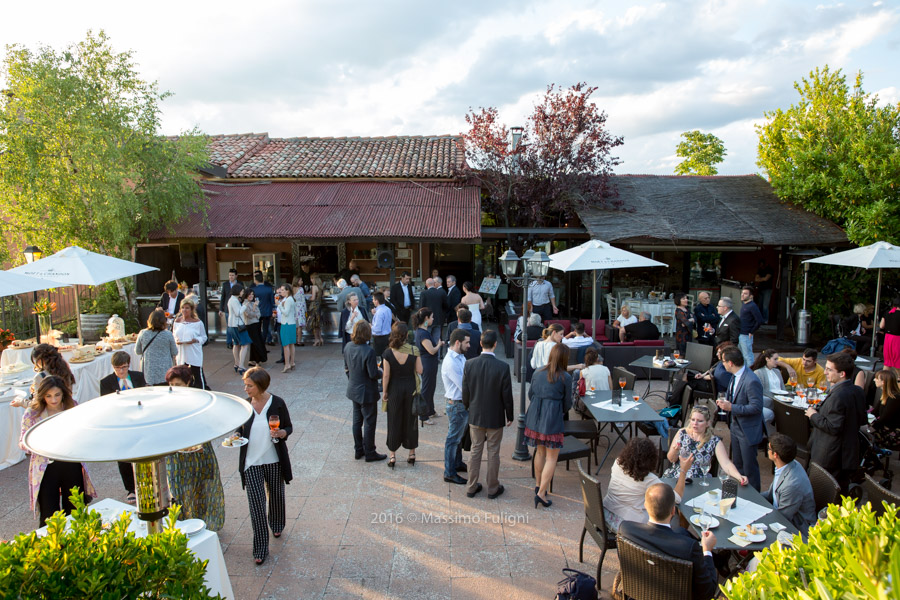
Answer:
663;406;748;485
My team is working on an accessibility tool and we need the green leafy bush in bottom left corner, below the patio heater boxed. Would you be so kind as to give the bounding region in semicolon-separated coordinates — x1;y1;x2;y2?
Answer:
0;493;220;600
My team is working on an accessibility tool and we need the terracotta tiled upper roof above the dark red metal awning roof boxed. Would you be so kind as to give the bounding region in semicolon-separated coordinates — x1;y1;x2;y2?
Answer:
209;133;465;179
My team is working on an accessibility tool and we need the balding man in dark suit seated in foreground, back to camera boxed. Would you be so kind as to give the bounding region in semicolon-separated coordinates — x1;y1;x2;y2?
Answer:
619;483;719;600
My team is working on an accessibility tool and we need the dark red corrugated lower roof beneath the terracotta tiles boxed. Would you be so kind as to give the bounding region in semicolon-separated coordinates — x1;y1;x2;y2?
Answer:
150;181;481;242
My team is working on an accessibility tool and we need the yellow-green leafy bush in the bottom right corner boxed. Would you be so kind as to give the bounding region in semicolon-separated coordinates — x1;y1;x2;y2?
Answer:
722;498;900;600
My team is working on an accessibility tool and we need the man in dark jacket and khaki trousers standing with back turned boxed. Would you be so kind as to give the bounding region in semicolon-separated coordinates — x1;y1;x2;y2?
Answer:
464;330;513;499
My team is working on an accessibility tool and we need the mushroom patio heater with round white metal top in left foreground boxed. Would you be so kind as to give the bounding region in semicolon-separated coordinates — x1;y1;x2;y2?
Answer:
24;387;252;533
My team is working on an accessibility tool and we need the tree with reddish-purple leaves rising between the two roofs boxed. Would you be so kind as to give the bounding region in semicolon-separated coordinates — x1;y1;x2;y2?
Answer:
463;83;623;254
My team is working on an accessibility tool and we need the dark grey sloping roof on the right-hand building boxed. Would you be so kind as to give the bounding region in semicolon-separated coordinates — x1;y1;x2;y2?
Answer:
577;175;847;247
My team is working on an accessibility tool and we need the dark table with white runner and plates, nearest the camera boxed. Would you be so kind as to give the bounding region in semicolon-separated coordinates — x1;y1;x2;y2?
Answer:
663;477;799;551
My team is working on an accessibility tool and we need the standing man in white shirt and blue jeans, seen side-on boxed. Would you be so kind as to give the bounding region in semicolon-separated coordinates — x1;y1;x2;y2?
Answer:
441;329;469;483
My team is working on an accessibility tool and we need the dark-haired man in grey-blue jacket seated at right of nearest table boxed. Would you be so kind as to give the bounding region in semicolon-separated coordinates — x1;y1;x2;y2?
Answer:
762;433;816;539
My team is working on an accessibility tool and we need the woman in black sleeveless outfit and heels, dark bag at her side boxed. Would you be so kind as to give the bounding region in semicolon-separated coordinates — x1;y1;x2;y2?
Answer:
381;322;422;469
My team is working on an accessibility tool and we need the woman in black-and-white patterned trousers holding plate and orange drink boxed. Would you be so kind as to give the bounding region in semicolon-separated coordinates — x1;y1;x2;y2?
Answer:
238;367;294;565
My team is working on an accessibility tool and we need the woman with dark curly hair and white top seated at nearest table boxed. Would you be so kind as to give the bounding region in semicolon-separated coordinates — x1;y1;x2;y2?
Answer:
603;437;694;531
